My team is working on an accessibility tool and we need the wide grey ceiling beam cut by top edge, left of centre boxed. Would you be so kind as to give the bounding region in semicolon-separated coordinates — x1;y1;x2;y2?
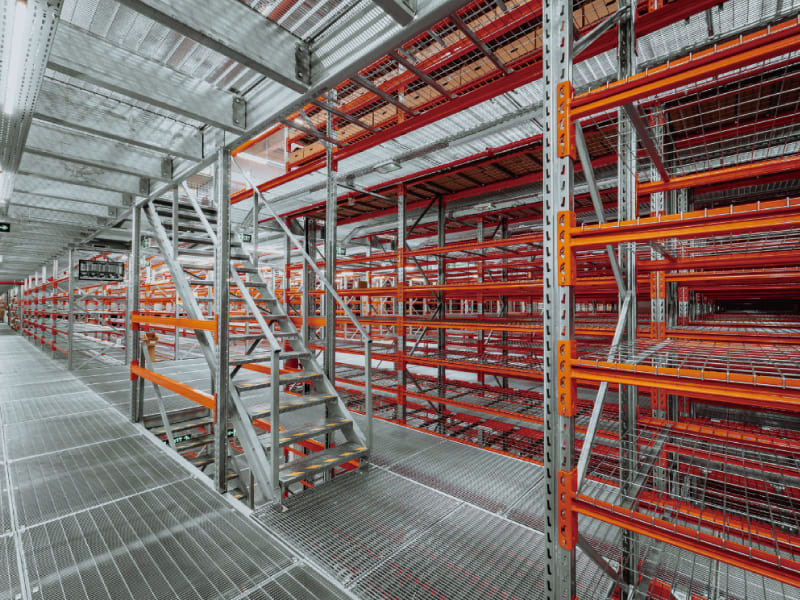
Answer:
118;0;308;92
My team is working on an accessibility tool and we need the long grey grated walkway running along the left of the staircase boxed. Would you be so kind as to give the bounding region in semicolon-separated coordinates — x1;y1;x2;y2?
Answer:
0;325;350;600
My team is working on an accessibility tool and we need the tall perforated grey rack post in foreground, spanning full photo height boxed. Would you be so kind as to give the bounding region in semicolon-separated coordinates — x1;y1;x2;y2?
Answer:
542;0;578;600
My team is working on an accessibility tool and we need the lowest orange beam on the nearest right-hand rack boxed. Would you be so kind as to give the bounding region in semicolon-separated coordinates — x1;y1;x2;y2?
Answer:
572;494;800;587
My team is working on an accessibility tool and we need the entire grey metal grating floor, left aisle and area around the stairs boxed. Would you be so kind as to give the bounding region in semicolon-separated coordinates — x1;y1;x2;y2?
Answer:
0;329;798;600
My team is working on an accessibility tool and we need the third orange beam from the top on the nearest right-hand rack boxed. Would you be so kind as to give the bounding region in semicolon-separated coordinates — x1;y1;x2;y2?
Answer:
572;359;800;412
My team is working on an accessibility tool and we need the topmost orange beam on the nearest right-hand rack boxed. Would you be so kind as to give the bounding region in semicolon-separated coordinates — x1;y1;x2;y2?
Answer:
570;18;800;119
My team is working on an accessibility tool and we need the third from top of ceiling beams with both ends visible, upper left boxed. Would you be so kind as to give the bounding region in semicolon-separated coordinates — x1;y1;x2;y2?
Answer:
25;119;172;180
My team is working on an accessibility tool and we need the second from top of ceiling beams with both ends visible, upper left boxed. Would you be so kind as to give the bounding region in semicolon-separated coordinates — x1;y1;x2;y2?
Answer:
34;78;203;160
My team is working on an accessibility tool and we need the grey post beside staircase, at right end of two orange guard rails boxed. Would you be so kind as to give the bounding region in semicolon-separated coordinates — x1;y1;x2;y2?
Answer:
214;149;231;494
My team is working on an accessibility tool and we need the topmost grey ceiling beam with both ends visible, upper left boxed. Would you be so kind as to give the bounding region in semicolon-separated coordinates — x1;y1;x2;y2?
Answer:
48;22;246;133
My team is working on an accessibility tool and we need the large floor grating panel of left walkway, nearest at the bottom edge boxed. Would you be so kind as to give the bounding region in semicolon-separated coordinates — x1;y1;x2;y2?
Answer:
23;481;292;600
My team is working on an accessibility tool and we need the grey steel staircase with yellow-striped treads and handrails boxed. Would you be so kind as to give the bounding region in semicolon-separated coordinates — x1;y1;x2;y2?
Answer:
146;192;368;505
